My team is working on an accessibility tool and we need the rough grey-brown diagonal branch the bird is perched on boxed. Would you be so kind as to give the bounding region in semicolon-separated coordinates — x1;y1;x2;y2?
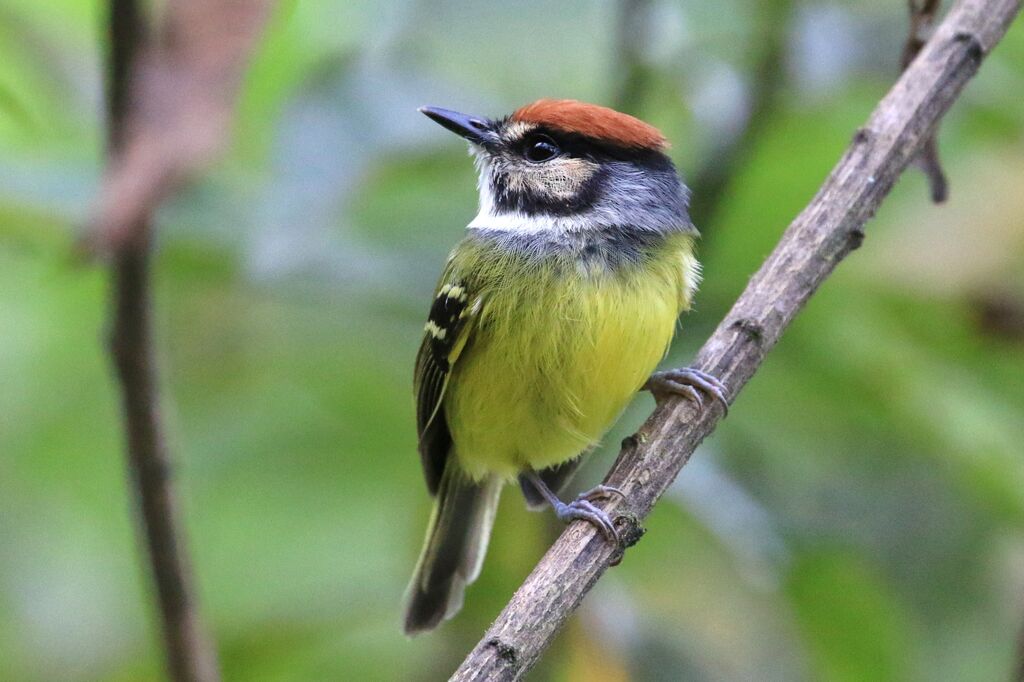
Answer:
452;0;1020;681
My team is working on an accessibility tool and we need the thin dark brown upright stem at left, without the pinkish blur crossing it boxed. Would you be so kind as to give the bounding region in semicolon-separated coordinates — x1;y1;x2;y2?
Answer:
108;0;219;682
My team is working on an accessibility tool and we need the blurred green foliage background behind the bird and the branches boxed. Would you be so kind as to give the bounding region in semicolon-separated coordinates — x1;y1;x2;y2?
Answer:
0;0;1024;681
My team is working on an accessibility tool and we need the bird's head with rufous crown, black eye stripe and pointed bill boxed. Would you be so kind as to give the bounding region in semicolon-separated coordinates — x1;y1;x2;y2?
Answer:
420;99;693;231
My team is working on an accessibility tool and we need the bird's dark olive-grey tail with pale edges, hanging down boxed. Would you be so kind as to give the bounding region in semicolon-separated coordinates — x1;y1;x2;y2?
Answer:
404;460;502;635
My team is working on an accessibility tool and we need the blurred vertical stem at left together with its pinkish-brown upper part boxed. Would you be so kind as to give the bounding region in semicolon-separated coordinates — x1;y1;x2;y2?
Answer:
100;0;269;682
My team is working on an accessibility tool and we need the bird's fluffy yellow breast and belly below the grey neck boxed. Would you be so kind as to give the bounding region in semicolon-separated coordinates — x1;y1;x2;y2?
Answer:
444;240;697;478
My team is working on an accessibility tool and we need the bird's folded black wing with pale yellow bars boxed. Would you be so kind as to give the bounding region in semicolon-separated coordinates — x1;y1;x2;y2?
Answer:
416;284;472;495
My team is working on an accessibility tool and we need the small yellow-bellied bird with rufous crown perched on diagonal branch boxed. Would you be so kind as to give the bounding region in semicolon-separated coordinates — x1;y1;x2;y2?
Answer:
404;99;727;634
